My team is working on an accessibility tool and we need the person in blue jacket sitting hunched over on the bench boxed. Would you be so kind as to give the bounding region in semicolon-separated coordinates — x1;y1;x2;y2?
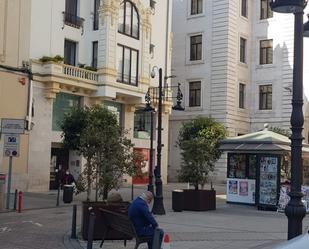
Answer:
128;191;164;249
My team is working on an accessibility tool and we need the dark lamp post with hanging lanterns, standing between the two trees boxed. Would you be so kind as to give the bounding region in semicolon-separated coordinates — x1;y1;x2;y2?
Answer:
146;66;184;215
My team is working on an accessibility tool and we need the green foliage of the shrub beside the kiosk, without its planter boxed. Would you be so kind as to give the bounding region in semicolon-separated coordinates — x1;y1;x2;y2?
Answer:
177;117;226;190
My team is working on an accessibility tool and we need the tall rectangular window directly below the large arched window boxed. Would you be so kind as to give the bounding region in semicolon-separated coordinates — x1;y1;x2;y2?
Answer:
117;45;138;86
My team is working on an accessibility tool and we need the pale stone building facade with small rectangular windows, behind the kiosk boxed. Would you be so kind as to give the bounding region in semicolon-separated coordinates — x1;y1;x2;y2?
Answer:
168;0;309;181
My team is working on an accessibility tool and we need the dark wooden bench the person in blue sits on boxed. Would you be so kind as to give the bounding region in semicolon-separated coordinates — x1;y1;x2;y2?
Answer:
100;208;152;249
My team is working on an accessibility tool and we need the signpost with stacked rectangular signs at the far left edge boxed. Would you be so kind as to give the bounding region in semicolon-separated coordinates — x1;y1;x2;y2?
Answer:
1;118;25;209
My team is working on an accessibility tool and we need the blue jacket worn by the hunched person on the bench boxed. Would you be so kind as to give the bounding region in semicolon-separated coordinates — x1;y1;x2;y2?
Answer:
128;197;158;236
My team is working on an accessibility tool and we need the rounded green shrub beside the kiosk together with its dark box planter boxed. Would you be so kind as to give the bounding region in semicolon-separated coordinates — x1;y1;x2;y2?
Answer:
177;117;226;211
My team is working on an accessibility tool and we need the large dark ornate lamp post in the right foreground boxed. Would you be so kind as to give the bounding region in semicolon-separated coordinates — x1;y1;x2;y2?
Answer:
269;0;308;240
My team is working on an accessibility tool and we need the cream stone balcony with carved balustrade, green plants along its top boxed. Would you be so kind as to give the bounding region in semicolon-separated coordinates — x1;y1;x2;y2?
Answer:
31;60;98;99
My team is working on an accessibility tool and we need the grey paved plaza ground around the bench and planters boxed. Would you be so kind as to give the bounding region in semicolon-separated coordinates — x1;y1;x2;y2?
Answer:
0;184;309;249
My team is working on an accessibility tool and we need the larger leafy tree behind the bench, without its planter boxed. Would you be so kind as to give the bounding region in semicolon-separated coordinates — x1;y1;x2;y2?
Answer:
61;106;142;201
